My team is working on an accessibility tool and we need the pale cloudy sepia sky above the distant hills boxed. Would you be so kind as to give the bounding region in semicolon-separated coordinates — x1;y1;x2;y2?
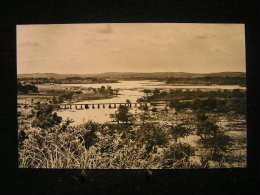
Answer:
17;23;245;74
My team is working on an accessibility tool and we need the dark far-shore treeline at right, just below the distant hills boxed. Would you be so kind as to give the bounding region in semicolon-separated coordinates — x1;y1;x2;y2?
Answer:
166;76;246;86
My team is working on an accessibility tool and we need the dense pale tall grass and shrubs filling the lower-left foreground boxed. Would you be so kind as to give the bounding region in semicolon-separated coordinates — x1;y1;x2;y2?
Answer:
19;117;201;168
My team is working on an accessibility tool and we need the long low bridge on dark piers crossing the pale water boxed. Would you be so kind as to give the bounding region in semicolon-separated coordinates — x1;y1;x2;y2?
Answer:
17;102;165;110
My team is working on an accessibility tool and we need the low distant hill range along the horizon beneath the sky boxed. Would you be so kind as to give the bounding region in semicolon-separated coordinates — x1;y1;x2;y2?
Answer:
17;72;246;79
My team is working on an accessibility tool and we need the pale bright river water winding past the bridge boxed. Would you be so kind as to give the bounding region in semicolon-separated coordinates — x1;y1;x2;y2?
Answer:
57;80;245;125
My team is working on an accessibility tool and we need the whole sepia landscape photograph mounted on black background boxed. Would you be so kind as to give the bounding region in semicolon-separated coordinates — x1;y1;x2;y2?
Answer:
16;23;247;169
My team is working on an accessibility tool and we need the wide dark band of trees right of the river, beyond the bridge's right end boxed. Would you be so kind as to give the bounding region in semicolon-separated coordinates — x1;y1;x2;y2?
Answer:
138;89;247;114
